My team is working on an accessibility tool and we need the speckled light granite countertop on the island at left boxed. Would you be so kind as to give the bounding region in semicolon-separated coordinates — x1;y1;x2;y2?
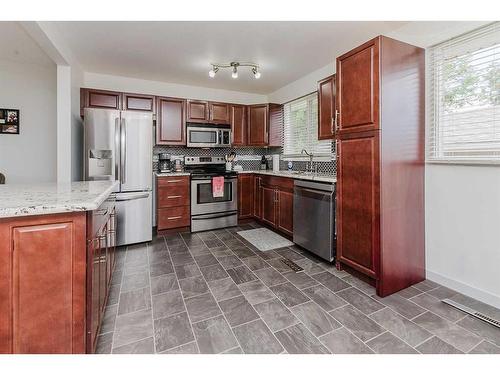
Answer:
0;181;118;218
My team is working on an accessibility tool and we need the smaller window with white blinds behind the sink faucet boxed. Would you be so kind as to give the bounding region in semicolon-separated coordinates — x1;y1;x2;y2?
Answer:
283;92;332;160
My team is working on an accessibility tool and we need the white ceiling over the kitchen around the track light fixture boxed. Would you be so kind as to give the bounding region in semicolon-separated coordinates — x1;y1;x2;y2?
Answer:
51;21;407;94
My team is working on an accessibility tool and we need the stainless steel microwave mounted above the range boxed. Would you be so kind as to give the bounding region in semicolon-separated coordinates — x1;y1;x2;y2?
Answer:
187;124;231;147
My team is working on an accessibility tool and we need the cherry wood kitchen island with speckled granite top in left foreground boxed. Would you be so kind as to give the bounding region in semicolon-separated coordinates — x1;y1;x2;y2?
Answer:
0;181;117;353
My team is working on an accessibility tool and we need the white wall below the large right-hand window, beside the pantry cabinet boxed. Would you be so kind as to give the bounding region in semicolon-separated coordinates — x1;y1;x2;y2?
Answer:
425;164;500;308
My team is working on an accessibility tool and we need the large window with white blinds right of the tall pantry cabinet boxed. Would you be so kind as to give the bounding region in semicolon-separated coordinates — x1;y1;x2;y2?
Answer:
427;22;500;163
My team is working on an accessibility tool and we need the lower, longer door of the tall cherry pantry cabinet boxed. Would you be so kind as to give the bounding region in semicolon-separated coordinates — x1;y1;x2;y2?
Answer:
337;131;380;278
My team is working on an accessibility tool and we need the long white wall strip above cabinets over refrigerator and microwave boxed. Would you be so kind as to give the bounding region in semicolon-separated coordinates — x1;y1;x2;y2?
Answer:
83;72;267;104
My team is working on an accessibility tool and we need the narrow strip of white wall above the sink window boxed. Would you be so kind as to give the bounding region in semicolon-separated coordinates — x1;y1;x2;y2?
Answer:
268;61;335;104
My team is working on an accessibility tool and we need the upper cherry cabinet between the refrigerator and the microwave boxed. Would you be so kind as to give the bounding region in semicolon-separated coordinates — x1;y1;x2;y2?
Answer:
156;97;186;145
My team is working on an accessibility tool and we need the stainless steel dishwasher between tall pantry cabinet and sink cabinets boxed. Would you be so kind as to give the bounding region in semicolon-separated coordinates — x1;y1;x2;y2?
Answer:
293;180;337;262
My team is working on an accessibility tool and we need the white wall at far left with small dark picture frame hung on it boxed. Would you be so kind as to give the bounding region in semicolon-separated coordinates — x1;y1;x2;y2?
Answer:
0;60;56;183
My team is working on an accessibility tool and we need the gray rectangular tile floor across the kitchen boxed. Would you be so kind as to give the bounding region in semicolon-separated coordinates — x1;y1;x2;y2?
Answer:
97;224;500;354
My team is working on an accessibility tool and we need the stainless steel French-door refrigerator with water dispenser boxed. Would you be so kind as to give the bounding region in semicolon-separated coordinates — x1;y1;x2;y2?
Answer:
83;108;153;246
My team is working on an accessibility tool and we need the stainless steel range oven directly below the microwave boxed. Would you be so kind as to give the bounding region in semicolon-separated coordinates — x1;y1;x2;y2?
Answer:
184;156;238;232
